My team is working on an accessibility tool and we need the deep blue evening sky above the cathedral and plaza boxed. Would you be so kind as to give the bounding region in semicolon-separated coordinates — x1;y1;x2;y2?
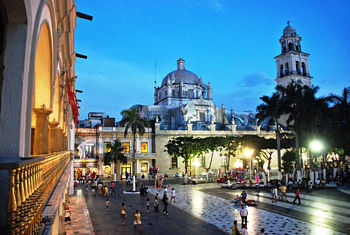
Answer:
75;0;350;119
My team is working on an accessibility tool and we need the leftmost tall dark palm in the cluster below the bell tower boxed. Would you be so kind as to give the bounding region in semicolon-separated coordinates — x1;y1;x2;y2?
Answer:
256;92;283;172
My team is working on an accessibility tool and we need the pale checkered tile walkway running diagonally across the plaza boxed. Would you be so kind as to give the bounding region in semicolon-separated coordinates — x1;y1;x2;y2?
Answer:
150;184;344;235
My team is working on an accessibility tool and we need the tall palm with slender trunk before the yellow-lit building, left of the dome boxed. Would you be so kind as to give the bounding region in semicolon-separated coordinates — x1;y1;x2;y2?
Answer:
119;107;148;188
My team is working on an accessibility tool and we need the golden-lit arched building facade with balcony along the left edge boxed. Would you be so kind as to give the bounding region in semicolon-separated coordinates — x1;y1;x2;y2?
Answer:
0;0;77;234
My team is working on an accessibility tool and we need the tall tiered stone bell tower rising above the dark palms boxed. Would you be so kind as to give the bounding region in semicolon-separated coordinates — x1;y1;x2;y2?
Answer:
274;21;312;87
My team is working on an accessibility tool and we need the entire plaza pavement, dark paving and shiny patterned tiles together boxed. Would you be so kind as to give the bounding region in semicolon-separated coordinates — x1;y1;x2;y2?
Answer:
67;182;350;235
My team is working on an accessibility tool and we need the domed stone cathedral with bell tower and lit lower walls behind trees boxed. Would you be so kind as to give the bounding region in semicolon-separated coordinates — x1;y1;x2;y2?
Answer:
76;22;312;178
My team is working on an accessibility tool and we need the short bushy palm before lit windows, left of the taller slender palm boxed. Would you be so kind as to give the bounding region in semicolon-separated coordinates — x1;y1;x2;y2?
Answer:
103;139;127;180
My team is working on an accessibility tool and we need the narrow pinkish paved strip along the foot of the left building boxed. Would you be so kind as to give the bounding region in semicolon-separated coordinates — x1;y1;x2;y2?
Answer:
65;189;95;235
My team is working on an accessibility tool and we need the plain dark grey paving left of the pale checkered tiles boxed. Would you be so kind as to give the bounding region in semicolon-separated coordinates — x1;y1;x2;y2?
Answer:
85;183;225;235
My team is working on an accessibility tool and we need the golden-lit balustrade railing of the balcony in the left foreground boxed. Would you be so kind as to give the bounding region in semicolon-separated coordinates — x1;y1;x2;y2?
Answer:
0;151;71;234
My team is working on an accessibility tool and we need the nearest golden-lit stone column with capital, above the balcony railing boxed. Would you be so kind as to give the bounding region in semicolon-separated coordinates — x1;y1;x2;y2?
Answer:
33;107;52;155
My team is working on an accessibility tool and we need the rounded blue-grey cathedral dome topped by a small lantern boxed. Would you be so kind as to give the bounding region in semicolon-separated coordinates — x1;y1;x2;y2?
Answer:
162;58;202;86
